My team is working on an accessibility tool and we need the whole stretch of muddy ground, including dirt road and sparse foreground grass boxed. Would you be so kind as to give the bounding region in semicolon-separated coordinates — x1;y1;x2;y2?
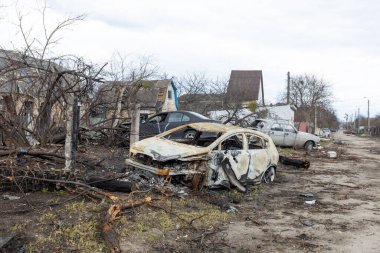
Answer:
0;133;380;252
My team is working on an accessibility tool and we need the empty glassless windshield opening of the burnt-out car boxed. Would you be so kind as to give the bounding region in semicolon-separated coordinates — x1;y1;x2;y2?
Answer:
162;127;223;147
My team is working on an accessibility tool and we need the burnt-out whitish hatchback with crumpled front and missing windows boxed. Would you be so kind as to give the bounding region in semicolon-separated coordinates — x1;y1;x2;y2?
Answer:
126;123;279;192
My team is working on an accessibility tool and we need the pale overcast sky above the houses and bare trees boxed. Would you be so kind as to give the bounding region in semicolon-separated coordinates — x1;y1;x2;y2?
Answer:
0;0;380;119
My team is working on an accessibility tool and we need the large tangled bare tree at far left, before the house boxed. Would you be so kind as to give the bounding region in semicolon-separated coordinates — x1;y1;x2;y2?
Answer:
0;7;100;152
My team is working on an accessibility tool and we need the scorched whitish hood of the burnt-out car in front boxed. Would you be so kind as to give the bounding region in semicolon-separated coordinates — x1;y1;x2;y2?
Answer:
130;137;209;162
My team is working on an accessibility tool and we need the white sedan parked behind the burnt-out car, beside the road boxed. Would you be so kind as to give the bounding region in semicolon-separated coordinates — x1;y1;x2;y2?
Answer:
251;119;321;150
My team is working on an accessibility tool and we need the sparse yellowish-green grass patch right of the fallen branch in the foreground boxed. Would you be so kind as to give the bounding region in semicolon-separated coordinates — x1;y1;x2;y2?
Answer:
117;197;231;242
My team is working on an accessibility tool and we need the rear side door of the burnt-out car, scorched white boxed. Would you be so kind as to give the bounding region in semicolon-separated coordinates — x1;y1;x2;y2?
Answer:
246;133;271;181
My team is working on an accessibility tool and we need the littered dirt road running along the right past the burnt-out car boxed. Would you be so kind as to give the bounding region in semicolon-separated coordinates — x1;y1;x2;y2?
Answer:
211;133;380;252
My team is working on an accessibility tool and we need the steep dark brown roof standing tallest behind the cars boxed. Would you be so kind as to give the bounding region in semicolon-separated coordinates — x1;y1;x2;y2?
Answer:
227;70;263;102
